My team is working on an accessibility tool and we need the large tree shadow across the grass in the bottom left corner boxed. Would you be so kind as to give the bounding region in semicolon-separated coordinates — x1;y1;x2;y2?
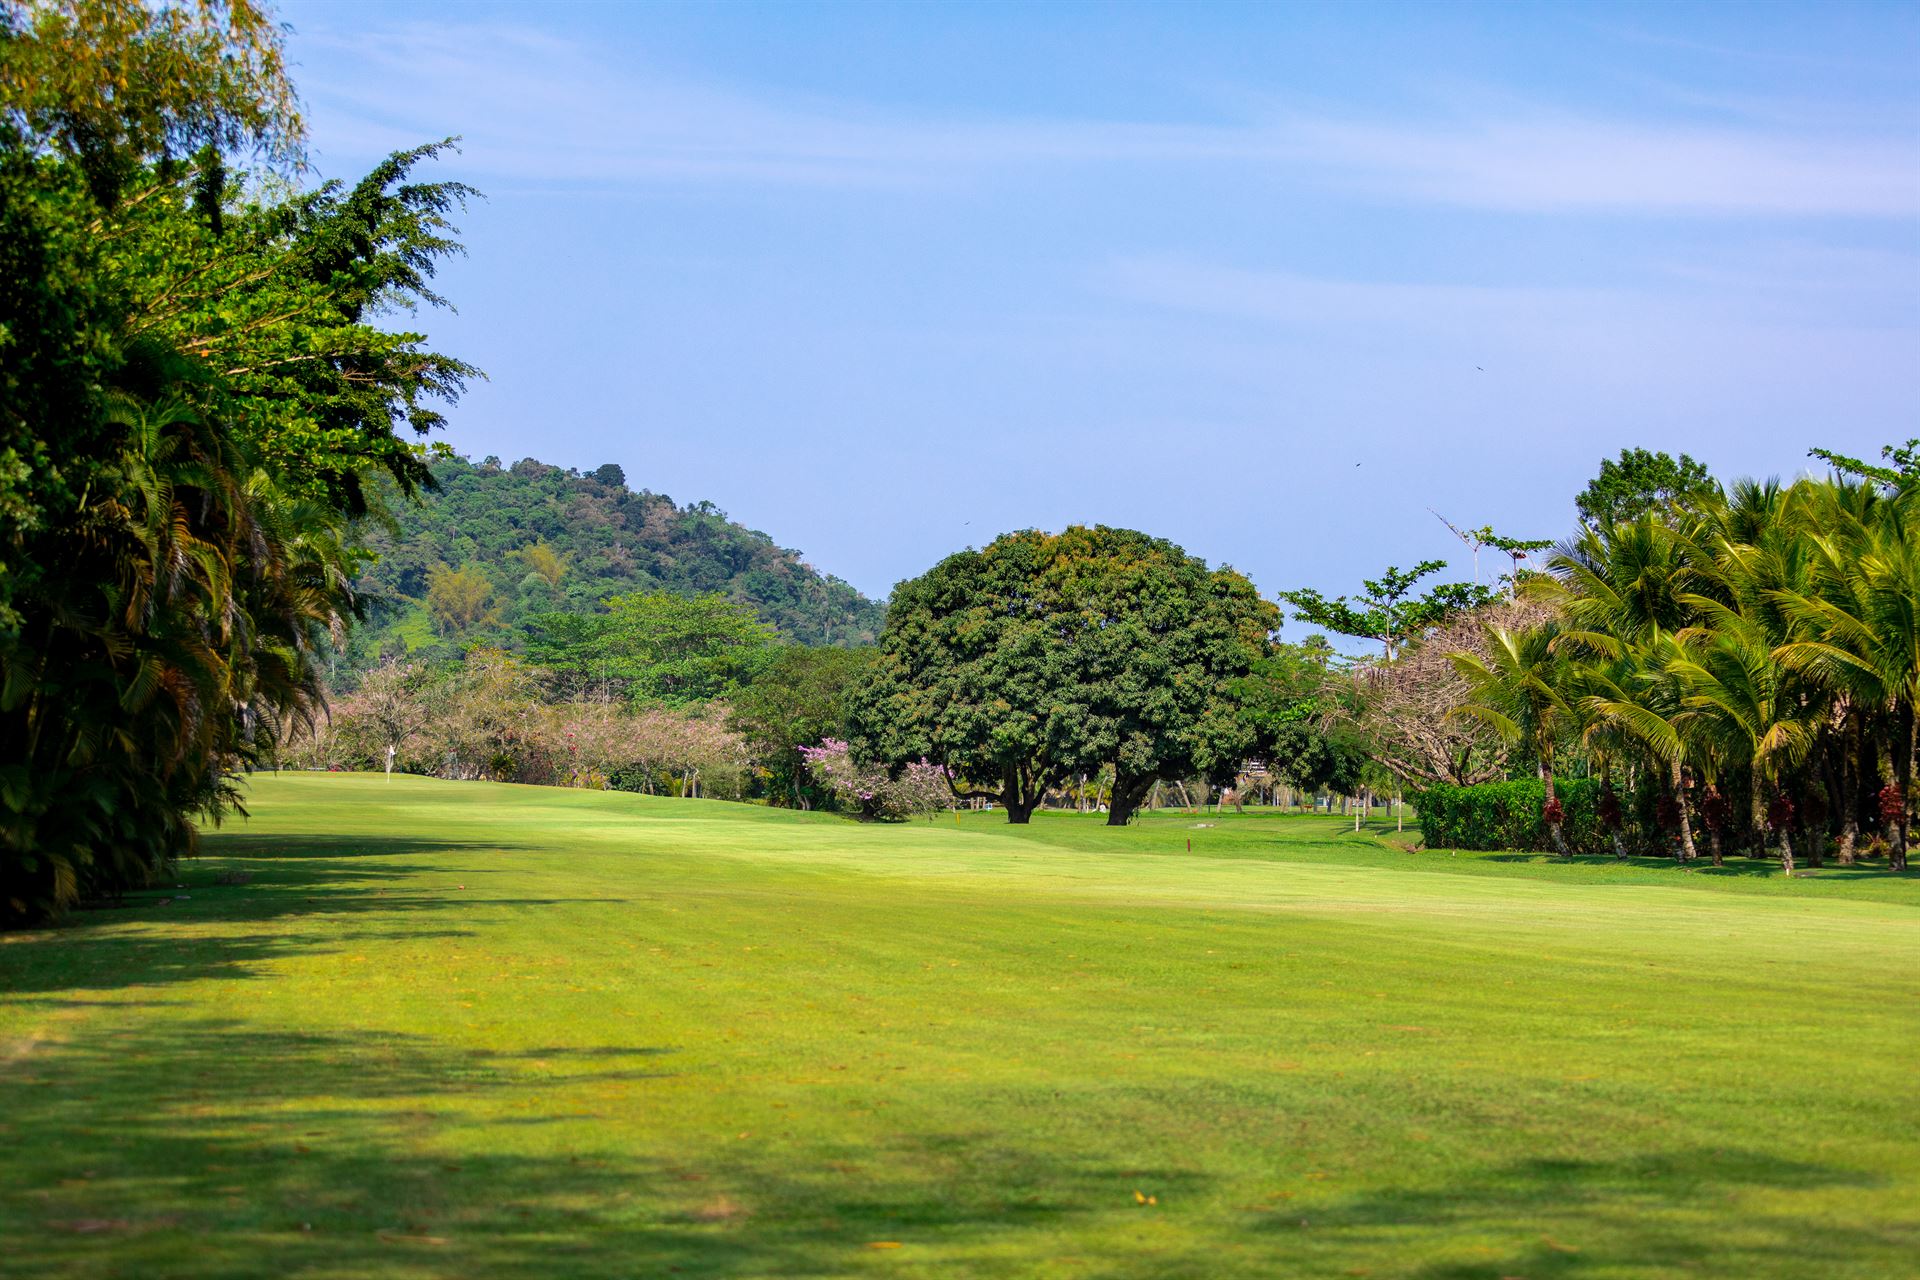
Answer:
0;1019;1202;1280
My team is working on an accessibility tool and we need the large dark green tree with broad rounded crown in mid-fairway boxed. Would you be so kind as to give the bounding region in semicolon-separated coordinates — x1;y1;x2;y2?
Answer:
851;526;1279;825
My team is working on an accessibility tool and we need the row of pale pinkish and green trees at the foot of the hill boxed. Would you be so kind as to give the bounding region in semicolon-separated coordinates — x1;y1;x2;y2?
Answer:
288;591;870;808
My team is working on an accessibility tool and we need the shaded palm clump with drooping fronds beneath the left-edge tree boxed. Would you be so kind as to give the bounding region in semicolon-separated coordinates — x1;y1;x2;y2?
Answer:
0;378;351;915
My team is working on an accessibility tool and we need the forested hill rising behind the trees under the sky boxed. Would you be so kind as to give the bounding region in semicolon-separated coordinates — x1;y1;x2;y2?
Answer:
349;457;885;668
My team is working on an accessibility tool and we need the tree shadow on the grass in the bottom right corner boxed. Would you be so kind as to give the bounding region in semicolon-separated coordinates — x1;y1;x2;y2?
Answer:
1273;1148;1920;1280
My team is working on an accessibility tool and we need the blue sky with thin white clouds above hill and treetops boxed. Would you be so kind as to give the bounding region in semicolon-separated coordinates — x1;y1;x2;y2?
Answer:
282;2;1920;610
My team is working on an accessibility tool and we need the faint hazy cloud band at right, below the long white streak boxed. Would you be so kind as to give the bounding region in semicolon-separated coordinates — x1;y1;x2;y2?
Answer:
1092;255;1916;397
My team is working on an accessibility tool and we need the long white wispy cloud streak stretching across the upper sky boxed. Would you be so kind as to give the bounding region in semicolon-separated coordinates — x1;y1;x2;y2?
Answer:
301;25;1920;219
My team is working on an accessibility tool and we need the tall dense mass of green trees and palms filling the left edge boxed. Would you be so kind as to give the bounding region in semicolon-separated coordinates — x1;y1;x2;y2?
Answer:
0;0;470;919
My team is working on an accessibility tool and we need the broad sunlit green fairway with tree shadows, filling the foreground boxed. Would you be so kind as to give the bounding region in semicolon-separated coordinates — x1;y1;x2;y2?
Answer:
0;775;1920;1280
